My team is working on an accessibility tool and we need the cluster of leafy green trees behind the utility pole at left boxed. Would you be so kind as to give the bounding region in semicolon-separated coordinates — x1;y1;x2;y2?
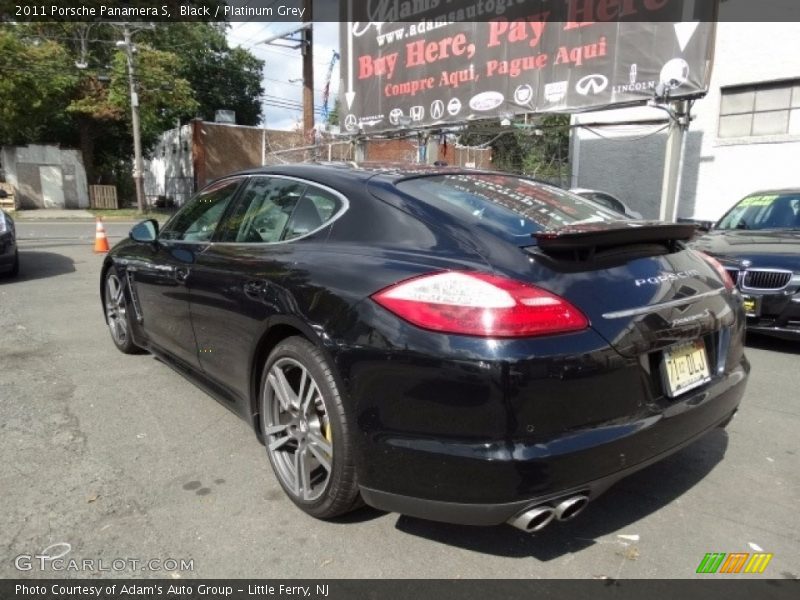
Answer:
0;21;263;192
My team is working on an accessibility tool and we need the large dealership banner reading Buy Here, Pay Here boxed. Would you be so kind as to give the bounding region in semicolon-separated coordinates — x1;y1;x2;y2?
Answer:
340;0;715;134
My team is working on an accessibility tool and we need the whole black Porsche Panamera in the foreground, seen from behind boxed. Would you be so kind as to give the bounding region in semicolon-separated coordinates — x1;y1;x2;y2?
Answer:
101;165;749;531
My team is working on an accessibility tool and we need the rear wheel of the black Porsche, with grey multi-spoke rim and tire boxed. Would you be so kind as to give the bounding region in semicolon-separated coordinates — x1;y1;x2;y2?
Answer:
259;337;361;519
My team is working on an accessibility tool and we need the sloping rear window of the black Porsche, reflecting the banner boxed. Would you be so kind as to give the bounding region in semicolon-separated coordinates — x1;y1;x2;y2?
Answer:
397;173;621;243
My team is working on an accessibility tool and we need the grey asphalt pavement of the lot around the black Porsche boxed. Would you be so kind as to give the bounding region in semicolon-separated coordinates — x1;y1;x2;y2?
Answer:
0;221;800;578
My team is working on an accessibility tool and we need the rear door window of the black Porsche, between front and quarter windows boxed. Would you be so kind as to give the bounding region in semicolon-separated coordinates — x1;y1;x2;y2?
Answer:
220;177;306;243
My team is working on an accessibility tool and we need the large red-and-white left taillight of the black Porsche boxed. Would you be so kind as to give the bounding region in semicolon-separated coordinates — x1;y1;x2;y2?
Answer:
372;271;589;337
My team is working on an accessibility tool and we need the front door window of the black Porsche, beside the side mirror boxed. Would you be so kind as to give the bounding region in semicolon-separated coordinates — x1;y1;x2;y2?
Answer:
160;178;241;242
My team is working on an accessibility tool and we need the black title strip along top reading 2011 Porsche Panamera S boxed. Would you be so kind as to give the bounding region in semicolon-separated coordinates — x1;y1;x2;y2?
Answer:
0;0;800;23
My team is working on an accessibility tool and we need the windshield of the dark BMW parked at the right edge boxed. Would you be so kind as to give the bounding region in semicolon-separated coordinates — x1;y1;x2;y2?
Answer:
716;192;800;230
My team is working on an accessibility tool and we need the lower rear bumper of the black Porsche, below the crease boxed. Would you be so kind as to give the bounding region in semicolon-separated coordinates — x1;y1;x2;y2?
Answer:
361;359;749;525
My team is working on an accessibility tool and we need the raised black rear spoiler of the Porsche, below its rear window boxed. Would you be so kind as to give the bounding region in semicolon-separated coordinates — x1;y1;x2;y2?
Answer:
533;221;697;252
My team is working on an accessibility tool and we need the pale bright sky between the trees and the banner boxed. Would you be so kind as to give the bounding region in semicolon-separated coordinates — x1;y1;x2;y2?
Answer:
228;21;339;130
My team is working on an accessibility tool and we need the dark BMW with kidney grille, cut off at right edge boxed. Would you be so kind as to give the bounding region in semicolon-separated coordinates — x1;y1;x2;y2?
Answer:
693;189;800;340
